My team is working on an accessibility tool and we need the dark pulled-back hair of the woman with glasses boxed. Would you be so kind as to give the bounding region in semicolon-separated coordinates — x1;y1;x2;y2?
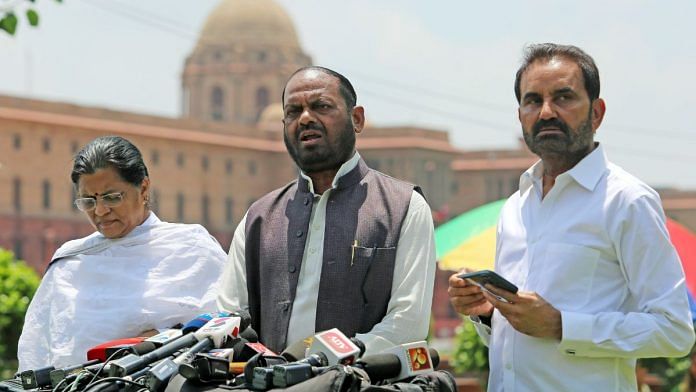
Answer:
70;136;148;186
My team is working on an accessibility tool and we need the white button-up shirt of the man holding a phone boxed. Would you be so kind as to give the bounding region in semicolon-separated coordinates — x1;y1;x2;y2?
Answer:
477;145;694;391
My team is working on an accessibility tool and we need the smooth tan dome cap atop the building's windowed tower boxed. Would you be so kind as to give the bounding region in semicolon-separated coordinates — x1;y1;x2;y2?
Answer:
197;0;300;49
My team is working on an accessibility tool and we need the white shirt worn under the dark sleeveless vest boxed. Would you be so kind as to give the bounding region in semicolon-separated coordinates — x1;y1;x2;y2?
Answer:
218;152;435;355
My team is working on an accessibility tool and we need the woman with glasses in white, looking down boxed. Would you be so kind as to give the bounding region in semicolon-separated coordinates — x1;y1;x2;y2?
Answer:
18;136;226;371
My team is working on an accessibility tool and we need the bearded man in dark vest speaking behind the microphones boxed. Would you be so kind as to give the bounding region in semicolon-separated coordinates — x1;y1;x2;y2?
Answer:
218;66;435;354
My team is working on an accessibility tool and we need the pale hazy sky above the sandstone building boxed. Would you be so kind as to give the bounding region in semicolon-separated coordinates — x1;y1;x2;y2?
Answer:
0;0;696;189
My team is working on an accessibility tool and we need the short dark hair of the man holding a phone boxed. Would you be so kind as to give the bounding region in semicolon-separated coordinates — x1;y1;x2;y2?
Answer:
515;43;599;102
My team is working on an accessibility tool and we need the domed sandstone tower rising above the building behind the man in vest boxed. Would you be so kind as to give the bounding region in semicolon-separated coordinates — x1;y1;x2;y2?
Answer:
182;0;312;125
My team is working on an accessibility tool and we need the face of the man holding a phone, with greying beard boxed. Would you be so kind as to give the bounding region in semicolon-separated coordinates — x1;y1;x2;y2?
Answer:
518;57;604;156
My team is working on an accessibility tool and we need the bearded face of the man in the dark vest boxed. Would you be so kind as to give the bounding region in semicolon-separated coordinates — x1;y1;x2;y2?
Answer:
283;70;364;173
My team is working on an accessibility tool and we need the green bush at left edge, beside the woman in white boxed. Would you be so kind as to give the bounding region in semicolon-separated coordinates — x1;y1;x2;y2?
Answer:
0;249;40;379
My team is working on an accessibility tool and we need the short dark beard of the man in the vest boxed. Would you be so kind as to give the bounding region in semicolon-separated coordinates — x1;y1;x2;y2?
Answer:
283;118;356;174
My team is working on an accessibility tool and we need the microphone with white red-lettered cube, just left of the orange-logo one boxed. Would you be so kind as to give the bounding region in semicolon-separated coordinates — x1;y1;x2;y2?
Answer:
307;328;365;365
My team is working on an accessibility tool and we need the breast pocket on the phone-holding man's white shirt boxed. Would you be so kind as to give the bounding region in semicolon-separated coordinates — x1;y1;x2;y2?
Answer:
532;243;599;311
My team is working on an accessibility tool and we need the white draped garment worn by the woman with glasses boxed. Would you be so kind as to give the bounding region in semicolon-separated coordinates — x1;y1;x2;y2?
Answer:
18;213;226;371
